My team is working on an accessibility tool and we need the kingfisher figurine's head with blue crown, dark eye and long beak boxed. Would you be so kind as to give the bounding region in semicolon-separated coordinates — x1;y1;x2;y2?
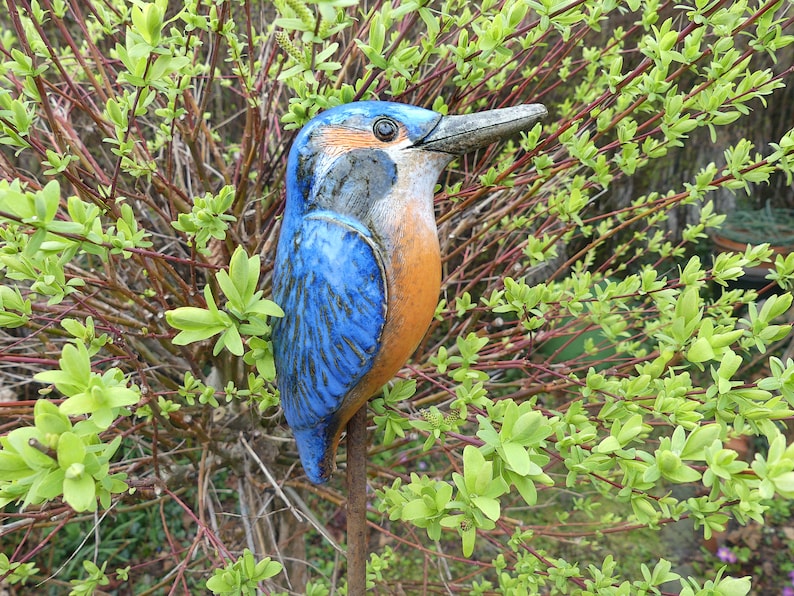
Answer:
285;101;546;225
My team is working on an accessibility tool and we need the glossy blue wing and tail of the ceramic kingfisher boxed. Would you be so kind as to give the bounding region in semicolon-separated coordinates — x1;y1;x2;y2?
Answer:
273;212;386;482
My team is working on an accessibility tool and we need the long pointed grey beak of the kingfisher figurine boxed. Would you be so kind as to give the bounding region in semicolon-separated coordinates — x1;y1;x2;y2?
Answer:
414;103;548;155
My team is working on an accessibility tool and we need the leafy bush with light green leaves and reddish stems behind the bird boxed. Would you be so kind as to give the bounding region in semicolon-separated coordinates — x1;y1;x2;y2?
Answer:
0;0;794;594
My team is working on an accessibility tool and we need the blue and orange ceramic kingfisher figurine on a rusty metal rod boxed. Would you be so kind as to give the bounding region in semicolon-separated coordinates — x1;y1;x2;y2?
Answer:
272;101;546;484
